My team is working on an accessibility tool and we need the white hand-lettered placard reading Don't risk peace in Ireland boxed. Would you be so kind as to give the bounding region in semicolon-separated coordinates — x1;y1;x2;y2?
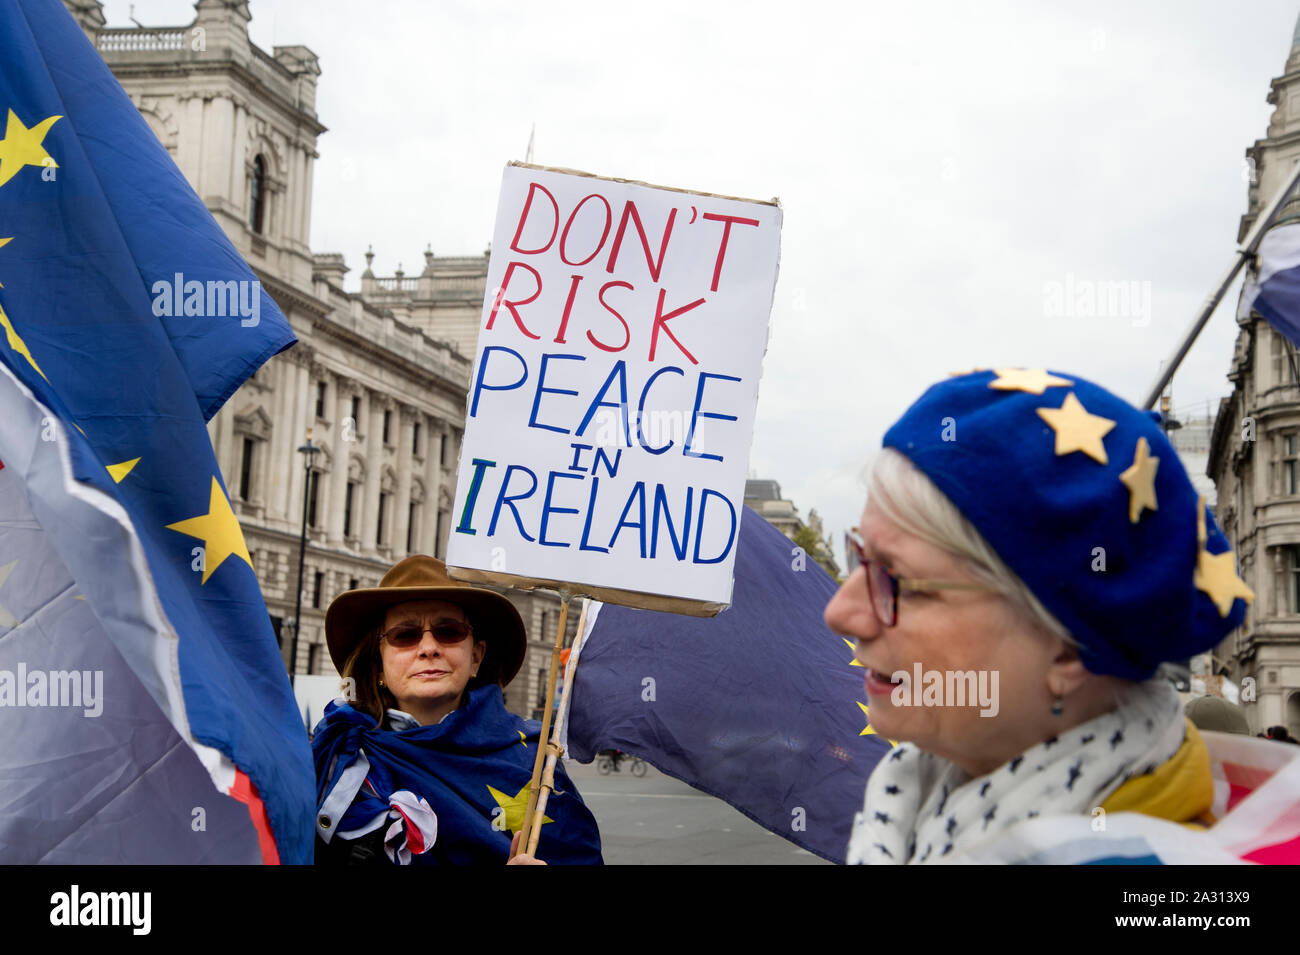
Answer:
447;164;781;616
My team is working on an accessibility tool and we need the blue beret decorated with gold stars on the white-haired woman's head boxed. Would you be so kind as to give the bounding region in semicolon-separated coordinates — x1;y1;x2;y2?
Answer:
884;368;1255;680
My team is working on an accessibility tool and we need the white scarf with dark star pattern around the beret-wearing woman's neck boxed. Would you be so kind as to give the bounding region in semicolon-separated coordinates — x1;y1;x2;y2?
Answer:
846;678;1187;865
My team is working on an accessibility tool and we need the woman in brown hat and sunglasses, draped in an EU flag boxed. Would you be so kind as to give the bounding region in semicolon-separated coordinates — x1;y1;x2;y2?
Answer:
312;556;602;865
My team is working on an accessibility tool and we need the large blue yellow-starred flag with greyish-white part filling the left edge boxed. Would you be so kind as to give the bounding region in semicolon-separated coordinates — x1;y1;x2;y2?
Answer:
0;0;312;863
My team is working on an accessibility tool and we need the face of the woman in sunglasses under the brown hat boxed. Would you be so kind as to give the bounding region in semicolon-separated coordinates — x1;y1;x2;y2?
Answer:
380;600;486;722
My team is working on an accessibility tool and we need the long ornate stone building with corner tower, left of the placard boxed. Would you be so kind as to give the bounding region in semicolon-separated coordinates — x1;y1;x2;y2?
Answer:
65;0;577;716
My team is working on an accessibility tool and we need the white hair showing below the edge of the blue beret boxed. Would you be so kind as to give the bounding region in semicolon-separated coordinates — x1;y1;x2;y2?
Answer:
867;448;1078;647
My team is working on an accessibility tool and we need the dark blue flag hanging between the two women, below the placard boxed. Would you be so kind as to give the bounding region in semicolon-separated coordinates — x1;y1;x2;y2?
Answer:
567;508;892;863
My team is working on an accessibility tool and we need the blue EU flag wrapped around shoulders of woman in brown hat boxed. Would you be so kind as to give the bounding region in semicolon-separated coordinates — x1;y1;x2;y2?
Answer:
312;685;602;865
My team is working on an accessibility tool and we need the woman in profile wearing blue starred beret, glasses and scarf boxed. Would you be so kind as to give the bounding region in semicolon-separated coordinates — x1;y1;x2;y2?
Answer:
826;369;1296;864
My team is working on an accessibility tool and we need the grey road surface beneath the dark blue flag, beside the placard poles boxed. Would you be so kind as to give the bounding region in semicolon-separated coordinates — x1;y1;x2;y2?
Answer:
564;760;829;865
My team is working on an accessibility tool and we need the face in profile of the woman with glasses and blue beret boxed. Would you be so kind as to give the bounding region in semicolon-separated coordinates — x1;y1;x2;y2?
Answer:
826;500;1060;776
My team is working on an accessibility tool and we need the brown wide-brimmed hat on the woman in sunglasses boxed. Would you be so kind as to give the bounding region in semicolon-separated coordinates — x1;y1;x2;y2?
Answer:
325;554;527;686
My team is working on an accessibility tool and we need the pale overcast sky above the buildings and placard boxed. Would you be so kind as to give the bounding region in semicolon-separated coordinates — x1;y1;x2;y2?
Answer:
105;0;1300;564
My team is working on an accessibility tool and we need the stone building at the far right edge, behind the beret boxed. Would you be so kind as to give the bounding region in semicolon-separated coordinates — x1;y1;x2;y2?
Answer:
1209;25;1300;735
